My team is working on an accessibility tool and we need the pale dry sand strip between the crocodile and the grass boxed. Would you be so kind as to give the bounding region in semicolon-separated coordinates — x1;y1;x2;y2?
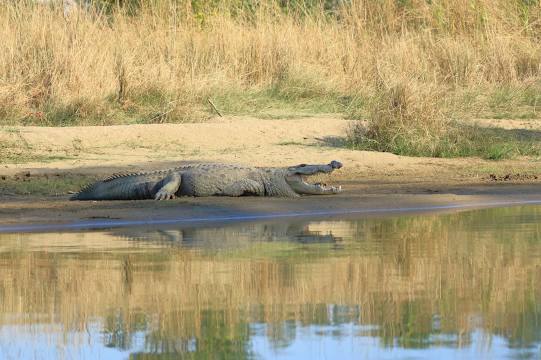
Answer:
0;117;464;175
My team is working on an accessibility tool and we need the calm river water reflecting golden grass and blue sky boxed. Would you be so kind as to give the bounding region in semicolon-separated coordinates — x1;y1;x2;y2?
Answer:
0;206;541;359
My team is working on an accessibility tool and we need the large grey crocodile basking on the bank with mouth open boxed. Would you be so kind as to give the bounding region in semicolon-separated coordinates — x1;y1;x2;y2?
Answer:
71;160;342;200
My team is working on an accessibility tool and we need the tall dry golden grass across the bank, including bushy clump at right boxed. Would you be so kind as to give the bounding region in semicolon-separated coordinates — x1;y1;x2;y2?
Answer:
0;0;541;159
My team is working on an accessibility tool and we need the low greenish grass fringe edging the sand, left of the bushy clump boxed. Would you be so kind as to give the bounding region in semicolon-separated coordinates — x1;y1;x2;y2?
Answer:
5;82;350;127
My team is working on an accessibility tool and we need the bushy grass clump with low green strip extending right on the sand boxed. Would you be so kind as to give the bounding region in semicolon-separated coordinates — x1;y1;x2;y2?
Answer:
348;86;541;160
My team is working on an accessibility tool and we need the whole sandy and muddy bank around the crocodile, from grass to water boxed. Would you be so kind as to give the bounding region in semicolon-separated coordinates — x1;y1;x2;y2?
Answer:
0;117;541;231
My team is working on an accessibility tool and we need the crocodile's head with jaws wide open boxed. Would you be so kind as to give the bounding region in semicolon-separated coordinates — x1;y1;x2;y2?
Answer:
285;160;342;195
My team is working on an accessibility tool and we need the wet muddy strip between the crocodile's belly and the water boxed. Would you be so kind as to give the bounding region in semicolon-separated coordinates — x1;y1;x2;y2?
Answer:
0;183;541;233
